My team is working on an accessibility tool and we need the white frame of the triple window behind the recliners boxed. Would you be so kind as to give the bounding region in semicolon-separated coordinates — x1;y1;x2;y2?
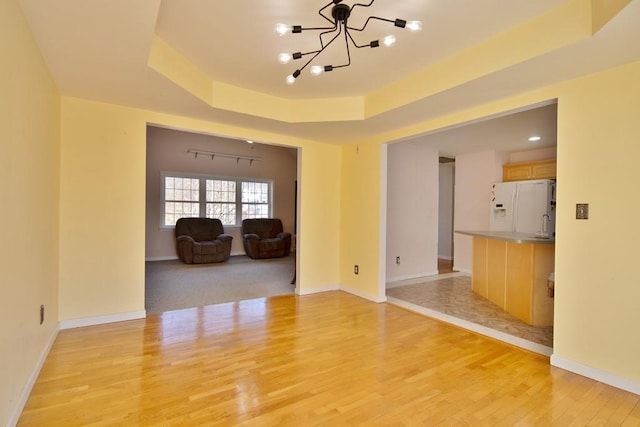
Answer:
159;171;274;230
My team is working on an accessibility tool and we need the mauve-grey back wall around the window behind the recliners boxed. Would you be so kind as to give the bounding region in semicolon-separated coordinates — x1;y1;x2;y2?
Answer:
145;126;297;260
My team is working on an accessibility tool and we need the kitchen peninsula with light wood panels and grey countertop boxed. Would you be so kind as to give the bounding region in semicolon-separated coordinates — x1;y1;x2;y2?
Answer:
456;230;555;326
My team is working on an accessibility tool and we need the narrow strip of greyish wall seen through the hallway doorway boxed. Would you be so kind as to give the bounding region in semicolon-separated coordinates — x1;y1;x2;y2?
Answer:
438;162;455;260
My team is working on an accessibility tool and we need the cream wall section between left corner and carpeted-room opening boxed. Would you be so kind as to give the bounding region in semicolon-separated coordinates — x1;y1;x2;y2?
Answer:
60;97;146;320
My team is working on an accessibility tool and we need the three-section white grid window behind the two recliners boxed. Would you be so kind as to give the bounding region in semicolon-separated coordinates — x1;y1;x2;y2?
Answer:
161;173;272;227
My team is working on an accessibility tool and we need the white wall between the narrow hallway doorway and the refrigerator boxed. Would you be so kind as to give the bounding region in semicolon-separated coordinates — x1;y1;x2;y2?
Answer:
453;150;508;273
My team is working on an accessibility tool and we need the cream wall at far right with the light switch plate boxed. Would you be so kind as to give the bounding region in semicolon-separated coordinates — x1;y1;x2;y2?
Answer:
554;62;640;384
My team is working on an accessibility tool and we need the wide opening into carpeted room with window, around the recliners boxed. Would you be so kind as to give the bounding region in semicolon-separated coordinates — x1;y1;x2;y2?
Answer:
145;126;299;313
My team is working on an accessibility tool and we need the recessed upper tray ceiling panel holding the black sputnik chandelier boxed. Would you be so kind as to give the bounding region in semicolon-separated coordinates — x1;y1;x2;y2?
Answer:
156;0;563;98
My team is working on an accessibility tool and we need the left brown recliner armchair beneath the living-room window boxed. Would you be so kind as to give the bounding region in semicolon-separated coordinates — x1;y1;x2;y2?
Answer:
176;218;233;264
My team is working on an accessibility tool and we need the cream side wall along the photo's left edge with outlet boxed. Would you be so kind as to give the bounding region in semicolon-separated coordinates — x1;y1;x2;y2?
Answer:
0;1;60;426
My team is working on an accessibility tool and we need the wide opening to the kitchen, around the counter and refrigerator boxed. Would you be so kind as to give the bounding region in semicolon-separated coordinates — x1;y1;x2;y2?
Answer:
383;100;557;355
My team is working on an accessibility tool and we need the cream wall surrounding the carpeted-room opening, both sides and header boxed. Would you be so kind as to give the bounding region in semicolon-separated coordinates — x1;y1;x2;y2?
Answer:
60;97;340;320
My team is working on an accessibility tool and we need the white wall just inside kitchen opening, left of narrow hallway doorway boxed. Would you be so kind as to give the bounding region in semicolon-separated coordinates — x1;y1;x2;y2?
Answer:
386;142;439;281
